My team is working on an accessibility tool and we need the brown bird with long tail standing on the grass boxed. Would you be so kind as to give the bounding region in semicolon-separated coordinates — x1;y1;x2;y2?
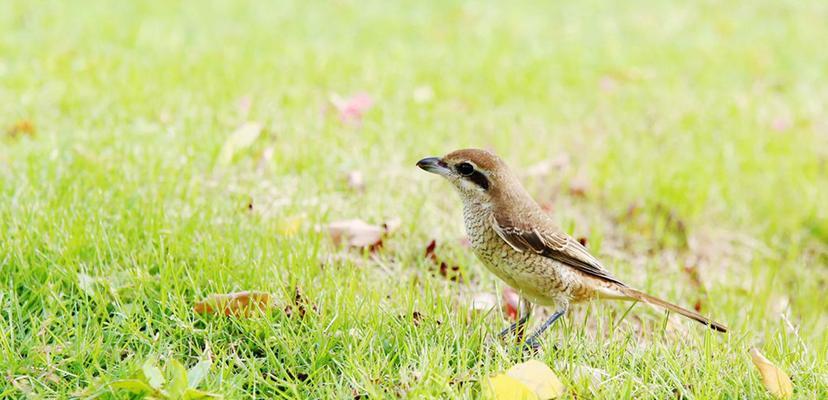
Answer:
417;149;727;348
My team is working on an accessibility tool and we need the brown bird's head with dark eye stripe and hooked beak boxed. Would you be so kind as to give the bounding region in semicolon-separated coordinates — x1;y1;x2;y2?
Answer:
417;149;520;203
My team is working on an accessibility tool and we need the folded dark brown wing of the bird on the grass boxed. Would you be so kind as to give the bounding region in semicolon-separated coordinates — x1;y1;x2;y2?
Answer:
493;218;627;286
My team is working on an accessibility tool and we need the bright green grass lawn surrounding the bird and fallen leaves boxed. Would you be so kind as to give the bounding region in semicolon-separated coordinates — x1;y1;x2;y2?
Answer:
0;0;828;399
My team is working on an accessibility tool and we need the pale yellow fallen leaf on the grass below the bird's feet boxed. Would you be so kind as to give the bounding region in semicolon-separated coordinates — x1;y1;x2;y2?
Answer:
486;360;564;400
